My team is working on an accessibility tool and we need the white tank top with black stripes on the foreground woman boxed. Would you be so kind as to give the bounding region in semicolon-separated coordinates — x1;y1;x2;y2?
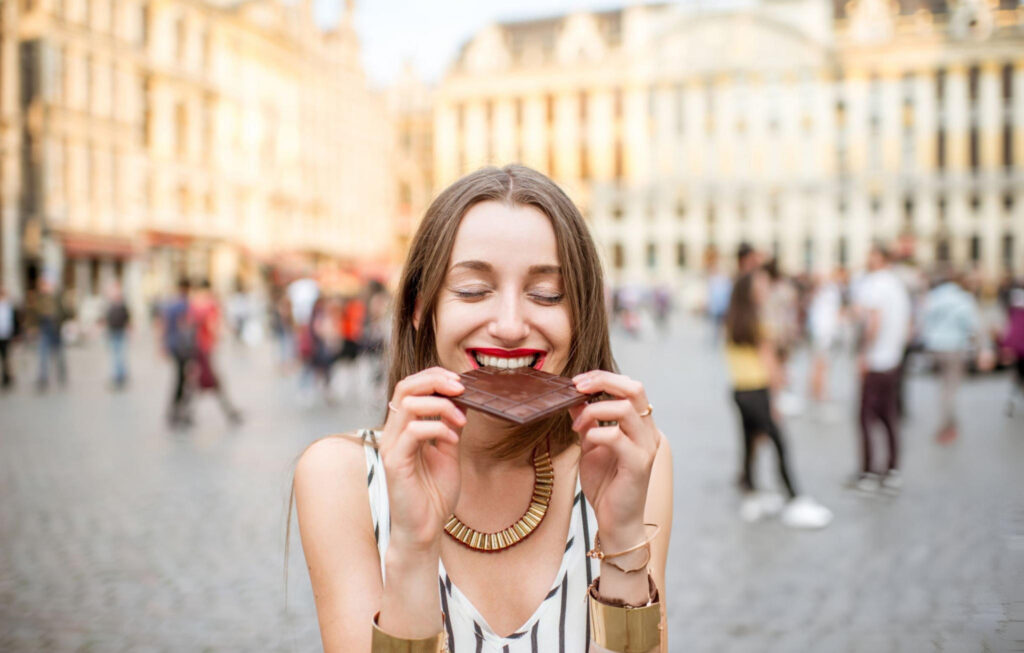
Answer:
359;430;599;653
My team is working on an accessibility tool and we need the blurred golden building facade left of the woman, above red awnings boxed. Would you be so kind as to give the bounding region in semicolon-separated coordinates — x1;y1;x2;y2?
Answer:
3;0;393;309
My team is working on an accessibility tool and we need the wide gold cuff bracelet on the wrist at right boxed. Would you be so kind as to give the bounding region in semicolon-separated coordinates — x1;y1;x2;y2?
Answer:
587;574;662;653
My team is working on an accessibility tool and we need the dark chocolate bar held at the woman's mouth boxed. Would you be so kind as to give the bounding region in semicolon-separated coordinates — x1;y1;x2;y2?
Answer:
451;367;590;424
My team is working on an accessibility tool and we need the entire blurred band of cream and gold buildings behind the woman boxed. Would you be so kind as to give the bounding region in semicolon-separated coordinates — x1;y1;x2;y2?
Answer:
0;0;1024;315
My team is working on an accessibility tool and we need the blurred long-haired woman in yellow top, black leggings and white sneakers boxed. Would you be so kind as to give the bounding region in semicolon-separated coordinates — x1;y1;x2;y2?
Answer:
725;270;831;528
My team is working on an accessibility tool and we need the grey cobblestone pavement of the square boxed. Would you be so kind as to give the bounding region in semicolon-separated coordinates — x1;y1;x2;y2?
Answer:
0;322;1024;653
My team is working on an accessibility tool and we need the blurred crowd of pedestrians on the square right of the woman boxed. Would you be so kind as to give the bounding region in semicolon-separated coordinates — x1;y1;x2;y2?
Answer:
705;244;1024;528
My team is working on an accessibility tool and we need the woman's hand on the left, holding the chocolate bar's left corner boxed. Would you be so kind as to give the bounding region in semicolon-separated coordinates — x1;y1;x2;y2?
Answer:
380;367;466;552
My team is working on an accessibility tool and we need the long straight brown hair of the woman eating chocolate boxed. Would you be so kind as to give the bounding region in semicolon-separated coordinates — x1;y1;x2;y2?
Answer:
384;165;615;460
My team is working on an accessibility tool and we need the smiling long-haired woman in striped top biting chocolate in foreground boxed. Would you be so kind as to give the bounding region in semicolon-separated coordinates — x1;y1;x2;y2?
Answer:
294;166;672;653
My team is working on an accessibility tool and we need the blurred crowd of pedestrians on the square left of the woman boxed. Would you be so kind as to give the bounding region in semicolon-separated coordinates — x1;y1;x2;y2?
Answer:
0;275;390;428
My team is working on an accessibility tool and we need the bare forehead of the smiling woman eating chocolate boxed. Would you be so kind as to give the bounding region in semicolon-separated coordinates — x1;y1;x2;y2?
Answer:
450;202;558;268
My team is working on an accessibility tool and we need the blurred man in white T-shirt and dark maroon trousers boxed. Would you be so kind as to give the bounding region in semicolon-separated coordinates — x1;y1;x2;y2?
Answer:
854;245;910;490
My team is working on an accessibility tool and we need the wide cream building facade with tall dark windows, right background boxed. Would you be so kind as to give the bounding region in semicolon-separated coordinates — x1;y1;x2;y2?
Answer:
434;0;1024;282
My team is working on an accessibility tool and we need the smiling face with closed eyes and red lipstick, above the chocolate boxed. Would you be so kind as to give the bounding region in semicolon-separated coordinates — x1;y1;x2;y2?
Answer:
435;202;571;374
